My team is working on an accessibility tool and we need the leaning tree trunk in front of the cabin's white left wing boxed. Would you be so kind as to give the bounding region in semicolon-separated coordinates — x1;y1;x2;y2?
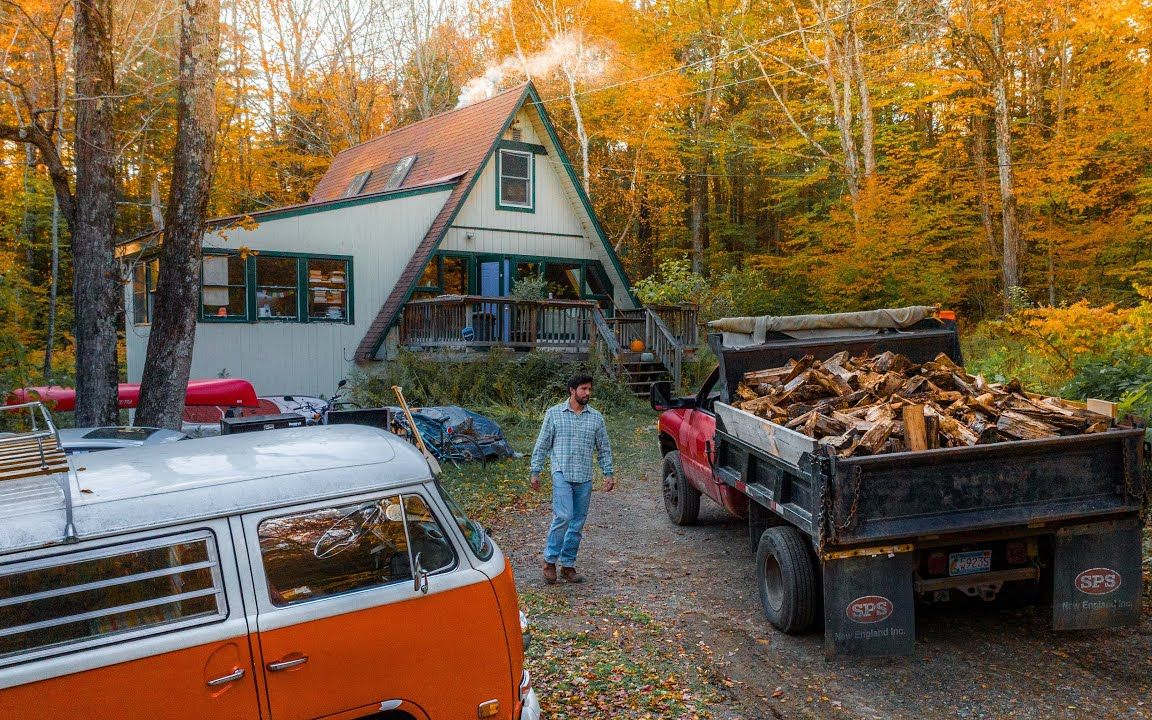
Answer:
136;0;220;429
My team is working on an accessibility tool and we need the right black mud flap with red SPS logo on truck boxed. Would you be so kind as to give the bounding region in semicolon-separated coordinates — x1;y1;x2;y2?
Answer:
1052;517;1144;630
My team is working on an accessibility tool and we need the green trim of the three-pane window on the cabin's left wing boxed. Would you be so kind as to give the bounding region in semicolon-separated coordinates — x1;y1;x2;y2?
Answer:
198;248;356;325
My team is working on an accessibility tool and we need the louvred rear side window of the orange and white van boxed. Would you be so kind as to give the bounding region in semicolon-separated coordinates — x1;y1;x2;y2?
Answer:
0;531;227;665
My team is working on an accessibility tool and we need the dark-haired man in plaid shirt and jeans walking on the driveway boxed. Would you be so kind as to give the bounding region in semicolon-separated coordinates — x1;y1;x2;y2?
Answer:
532;374;616;585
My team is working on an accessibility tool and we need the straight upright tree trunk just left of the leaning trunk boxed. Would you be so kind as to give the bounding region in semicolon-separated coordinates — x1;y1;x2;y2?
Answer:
72;0;123;427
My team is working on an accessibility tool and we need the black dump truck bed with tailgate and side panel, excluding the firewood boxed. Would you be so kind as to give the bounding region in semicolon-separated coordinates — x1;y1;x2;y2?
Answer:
715;403;1144;545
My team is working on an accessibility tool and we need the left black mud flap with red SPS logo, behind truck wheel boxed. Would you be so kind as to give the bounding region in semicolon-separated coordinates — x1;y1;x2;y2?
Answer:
824;548;916;660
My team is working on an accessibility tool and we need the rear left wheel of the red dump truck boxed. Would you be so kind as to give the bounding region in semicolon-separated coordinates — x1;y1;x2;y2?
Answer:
756;526;817;634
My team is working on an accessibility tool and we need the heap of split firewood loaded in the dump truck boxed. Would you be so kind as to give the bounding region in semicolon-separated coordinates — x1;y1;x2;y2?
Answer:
733;353;1113;457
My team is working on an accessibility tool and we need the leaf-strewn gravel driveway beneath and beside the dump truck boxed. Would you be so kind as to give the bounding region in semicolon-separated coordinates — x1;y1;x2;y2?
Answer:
498;440;1152;720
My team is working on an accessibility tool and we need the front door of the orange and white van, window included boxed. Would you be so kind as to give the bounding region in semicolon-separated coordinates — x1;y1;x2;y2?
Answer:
244;492;511;720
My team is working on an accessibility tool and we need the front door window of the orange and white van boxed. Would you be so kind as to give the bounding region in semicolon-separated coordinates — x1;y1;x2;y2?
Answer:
258;495;455;606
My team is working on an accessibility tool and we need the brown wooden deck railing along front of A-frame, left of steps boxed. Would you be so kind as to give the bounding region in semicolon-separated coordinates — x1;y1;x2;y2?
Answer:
400;295;596;353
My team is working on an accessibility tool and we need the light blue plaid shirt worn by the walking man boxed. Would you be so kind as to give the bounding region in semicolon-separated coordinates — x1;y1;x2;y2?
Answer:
532;400;613;483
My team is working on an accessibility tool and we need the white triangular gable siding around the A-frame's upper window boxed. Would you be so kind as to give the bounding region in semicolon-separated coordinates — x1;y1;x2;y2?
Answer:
440;109;632;308
